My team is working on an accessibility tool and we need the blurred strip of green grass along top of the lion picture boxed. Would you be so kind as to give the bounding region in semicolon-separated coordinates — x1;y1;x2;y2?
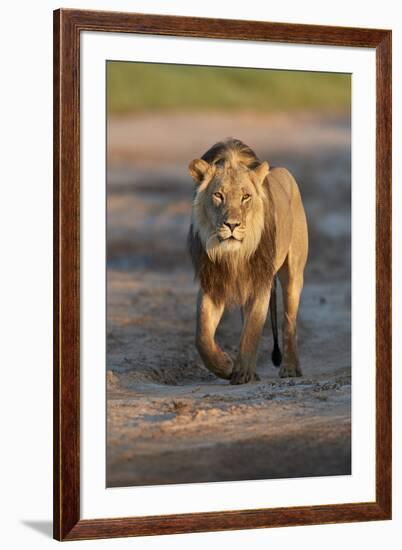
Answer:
107;61;351;113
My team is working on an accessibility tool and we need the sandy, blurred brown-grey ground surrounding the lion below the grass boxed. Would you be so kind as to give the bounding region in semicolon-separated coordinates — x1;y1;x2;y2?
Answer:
107;114;351;486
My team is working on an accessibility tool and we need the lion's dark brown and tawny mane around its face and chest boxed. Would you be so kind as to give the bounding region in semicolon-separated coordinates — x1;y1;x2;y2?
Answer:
188;138;275;306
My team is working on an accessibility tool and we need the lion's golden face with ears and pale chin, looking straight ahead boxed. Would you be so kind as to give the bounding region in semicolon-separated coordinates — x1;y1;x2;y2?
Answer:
189;159;268;261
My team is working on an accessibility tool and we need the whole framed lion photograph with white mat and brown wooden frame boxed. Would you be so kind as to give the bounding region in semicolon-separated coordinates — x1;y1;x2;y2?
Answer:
54;9;392;540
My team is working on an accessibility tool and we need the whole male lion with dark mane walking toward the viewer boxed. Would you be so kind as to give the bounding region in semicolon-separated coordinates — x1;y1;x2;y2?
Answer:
189;138;308;384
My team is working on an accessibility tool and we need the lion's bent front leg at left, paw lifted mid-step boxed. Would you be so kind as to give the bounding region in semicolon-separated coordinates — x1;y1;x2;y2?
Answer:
196;290;233;380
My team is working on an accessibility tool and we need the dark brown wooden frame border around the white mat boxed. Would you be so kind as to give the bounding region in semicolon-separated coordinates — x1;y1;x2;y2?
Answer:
53;9;392;540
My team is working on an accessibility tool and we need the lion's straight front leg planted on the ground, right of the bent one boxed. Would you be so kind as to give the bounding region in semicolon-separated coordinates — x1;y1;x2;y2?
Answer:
230;289;270;384
